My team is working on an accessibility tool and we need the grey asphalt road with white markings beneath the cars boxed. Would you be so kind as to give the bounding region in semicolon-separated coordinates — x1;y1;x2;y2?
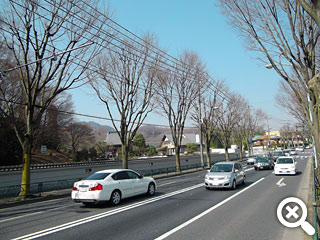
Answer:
0;151;311;240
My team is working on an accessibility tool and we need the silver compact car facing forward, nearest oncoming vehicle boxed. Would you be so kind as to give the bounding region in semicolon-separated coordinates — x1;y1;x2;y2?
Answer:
204;162;246;189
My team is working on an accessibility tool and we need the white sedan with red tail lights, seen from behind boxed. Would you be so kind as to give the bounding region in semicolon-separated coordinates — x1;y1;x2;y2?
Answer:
71;169;156;205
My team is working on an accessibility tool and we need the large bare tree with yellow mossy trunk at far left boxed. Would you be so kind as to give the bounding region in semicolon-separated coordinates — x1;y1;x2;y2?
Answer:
0;0;108;199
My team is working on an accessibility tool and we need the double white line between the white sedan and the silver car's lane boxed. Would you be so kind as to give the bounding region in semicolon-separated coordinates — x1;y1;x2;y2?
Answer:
13;183;204;240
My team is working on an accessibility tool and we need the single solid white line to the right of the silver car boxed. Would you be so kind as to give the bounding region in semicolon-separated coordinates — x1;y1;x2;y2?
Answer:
155;178;264;240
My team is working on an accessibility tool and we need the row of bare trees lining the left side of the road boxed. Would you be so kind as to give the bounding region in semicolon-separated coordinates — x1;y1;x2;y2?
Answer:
0;0;259;198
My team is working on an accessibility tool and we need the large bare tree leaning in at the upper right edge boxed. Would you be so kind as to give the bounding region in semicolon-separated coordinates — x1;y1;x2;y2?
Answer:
220;0;320;165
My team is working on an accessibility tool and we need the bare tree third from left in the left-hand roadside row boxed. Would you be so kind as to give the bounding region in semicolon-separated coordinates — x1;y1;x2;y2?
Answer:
156;51;205;172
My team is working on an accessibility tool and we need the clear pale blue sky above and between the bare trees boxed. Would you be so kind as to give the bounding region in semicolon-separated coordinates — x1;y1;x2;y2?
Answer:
71;0;293;131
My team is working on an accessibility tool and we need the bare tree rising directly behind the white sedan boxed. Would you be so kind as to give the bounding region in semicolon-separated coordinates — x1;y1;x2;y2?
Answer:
89;35;160;168
